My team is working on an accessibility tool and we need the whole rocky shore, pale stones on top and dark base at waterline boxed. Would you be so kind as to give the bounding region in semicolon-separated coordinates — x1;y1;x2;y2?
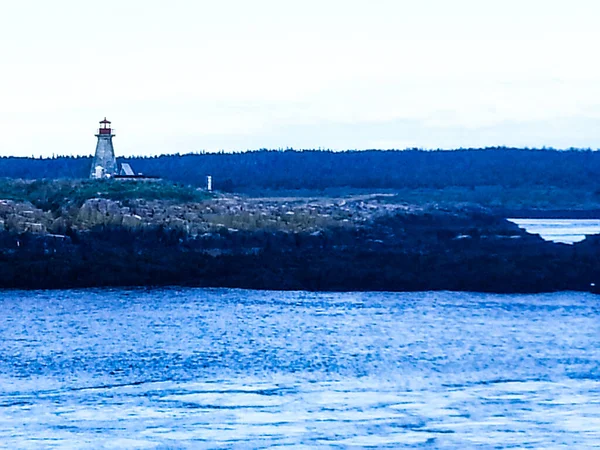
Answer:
0;190;600;293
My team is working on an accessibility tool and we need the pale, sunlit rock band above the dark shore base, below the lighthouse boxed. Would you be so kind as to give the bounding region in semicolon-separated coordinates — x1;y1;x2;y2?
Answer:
0;195;476;241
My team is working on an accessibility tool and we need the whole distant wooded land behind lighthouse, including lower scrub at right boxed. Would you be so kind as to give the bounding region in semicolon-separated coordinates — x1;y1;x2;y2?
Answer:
0;147;600;214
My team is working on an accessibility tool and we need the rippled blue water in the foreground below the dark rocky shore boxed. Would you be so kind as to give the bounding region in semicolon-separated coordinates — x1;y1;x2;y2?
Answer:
0;289;600;449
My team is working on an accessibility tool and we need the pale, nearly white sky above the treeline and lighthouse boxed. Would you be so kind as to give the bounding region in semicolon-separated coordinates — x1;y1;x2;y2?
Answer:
0;0;600;156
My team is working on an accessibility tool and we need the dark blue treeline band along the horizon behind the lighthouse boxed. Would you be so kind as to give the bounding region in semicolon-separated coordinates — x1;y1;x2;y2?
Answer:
0;148;600;192
